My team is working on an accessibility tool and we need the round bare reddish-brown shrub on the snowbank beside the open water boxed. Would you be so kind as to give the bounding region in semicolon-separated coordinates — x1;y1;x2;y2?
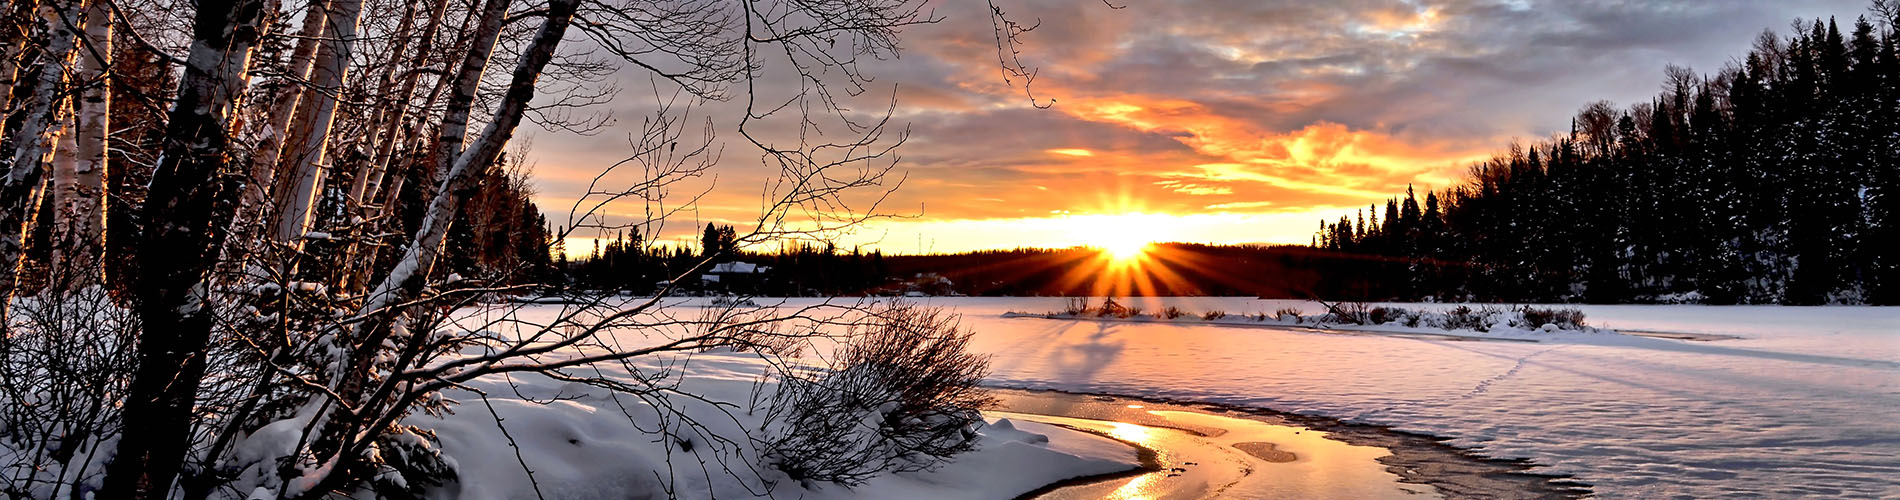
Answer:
760;302;994;485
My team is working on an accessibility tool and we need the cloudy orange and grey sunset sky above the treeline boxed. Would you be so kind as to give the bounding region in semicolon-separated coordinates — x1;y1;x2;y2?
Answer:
530;0;1866;253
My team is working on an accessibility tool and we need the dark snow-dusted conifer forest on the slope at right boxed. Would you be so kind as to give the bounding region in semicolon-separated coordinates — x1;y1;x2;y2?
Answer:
1313;17;1900;304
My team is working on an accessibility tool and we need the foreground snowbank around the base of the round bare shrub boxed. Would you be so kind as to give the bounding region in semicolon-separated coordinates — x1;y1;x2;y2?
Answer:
405;354;1138;500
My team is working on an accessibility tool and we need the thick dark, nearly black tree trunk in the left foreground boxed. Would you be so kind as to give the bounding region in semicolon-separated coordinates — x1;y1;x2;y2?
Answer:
101;0;277;498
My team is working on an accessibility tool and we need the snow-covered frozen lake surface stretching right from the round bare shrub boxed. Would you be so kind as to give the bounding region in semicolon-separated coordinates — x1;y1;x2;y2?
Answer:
482;297;1900;498
